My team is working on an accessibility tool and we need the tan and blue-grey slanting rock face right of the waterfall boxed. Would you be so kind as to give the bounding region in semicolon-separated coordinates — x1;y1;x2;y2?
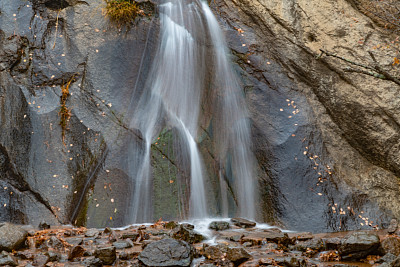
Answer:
211;0;400;231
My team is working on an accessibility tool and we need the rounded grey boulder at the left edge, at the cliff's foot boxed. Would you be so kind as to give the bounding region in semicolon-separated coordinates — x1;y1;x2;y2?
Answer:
0;223;28;251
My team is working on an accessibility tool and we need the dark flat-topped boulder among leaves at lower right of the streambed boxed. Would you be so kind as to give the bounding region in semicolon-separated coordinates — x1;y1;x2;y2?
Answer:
339;232;380;260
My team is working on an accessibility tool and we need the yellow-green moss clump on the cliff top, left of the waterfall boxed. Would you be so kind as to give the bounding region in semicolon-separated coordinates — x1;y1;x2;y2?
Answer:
105;0;140;27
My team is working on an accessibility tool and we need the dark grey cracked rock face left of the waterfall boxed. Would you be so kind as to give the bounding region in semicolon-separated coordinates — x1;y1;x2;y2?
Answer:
0;0;157;227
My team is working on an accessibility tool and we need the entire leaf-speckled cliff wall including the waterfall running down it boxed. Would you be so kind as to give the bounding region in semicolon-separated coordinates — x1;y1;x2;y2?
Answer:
0;0;400;231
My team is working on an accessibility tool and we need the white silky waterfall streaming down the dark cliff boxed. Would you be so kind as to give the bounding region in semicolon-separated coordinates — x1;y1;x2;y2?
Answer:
129;0;255;222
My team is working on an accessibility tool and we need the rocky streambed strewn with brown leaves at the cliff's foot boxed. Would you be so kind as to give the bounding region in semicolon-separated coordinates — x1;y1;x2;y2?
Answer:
0;218;400;267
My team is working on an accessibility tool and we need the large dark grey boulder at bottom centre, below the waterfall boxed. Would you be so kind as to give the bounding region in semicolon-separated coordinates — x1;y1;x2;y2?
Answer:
139;238;193;266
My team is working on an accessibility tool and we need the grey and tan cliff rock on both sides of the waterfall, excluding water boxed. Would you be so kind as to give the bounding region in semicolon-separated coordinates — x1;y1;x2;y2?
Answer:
0;0;400;231
